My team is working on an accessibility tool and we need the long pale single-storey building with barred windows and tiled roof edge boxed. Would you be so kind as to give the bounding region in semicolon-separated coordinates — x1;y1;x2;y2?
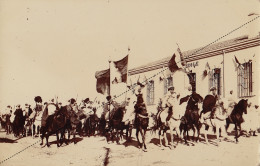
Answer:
129;35;260;113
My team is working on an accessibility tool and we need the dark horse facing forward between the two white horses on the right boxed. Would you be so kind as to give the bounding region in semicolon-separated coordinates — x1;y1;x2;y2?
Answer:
180;92;203;144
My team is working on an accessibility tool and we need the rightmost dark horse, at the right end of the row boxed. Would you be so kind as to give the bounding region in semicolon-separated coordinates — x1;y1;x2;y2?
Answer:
226;99;248;143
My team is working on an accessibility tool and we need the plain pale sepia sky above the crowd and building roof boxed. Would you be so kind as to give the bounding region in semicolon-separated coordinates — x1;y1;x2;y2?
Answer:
0;0;260;109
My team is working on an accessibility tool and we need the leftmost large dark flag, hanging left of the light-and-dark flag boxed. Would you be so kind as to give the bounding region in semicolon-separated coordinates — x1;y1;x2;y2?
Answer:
95;69;110;95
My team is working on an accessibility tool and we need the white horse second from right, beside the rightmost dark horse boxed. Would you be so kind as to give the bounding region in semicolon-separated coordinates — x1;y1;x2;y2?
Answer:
201;101;231;145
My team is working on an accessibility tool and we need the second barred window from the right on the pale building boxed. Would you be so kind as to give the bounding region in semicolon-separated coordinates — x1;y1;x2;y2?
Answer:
209;68;221;95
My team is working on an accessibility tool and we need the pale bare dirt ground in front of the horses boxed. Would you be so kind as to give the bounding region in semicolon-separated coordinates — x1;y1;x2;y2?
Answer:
0;126;260;166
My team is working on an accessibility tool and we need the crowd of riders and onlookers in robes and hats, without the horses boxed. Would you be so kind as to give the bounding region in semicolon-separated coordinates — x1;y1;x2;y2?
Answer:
0;84;259;148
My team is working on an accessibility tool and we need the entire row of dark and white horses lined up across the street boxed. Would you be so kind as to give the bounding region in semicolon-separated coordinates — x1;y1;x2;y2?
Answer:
0;93;252;151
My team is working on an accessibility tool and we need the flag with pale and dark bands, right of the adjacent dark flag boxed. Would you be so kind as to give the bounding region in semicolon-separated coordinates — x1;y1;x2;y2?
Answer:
112;55;128;84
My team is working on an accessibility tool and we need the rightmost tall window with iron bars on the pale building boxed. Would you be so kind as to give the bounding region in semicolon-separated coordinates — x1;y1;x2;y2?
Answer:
237;62;253;97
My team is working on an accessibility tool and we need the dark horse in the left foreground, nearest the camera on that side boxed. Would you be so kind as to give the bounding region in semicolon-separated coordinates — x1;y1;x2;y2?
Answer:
41;106;69;147
